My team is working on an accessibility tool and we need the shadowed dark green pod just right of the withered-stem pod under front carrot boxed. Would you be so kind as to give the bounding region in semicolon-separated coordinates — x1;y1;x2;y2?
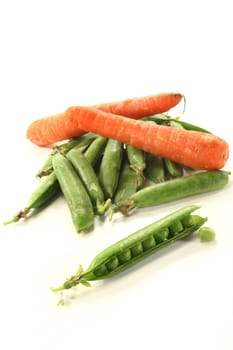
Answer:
144;153;166;183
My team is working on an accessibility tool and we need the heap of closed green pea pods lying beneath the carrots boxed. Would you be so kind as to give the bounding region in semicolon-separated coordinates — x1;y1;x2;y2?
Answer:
5;114;229;232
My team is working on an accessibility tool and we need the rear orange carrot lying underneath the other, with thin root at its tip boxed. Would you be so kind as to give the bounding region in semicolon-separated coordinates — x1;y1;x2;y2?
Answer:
27;93;183;146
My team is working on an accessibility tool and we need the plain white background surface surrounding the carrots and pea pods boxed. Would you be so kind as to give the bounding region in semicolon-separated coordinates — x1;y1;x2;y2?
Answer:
0;0;233;350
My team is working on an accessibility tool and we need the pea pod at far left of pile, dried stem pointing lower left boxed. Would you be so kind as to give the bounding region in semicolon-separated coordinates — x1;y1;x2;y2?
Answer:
5;172;60;224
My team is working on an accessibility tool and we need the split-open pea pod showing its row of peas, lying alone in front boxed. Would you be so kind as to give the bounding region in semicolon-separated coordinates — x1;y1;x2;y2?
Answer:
52;205;207;291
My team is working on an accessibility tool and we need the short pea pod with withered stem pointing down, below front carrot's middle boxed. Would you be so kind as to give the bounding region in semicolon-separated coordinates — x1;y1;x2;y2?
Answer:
126;145;146;189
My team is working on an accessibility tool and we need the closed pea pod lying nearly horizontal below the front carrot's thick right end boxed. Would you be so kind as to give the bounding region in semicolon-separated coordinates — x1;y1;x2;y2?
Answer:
119;170;230;213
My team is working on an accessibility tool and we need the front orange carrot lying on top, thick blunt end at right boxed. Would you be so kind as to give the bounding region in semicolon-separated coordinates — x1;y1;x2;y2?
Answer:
28;107;229;170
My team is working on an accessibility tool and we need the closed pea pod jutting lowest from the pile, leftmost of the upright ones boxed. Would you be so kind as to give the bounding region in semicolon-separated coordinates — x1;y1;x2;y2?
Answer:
52;153;94;233
